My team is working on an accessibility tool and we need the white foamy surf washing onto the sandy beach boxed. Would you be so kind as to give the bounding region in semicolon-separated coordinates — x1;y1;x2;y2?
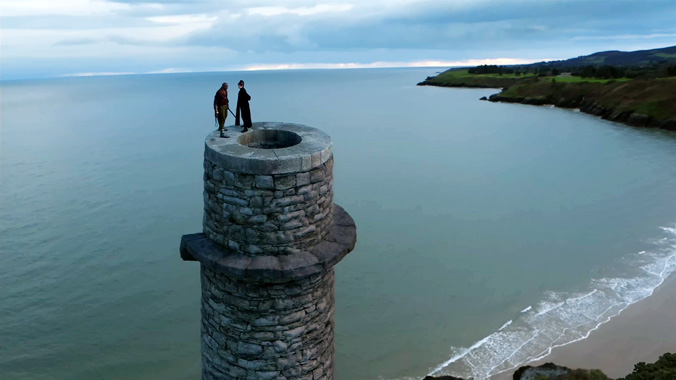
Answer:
429;226;676;380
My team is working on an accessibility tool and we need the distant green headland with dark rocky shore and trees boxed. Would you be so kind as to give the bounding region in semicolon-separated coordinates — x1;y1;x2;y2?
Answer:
418;46;676;130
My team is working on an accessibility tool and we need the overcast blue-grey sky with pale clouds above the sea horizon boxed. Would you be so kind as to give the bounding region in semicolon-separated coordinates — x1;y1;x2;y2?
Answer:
0;0;676;79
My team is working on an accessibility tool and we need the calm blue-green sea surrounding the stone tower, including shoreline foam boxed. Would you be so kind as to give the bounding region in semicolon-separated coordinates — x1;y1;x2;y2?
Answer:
0;69;676;380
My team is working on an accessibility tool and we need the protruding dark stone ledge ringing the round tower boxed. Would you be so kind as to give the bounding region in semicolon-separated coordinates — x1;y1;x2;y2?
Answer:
181;204;357;282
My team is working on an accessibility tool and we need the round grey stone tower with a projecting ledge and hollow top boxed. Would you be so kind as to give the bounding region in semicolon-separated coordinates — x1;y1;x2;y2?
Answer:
180;123;357;380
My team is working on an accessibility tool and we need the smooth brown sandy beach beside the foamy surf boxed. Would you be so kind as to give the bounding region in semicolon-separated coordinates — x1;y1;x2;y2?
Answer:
491;275;676;380
